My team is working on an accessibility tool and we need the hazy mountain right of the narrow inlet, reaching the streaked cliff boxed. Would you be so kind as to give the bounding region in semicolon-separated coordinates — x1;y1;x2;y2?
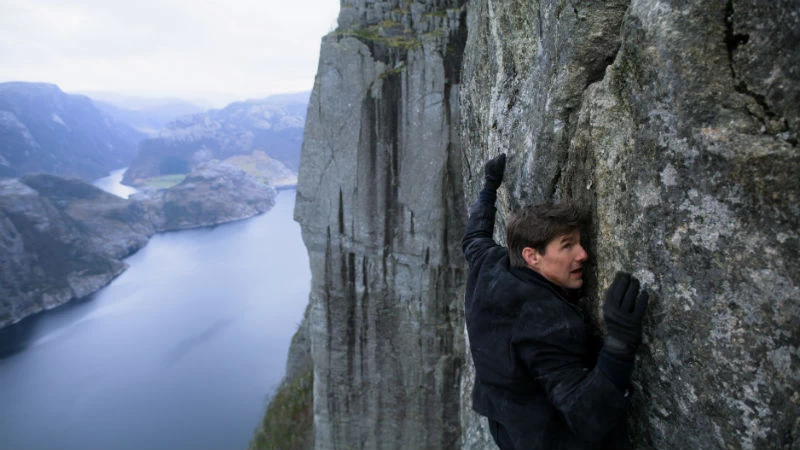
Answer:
123;92;309;186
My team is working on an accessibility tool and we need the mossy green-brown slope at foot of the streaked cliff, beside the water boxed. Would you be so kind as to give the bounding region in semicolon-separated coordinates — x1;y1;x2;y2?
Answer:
250;367;314;450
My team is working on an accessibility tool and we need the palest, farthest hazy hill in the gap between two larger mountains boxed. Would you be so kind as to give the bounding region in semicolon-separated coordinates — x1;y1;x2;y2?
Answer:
92;98;206;138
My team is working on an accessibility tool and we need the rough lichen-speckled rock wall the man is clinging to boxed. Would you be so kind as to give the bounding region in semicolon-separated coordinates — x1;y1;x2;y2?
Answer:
461;0;800;449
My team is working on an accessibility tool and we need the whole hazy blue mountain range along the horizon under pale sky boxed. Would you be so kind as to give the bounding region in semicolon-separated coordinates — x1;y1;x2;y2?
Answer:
0;82;310;186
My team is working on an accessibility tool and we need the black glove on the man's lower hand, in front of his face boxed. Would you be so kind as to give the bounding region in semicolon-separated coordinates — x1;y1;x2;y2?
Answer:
603;272;649;360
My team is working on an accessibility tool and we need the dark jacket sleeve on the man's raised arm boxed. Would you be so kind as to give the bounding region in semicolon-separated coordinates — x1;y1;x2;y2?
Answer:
461;189;498;266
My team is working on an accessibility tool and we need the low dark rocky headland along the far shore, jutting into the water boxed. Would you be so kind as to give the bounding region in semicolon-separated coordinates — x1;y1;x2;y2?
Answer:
0;162;275;327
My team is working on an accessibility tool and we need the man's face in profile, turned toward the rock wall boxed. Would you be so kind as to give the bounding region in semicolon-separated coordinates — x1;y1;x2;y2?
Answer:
529;230;589;289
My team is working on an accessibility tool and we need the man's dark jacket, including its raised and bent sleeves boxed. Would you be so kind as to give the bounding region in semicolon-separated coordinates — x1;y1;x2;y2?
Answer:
462;190;629;450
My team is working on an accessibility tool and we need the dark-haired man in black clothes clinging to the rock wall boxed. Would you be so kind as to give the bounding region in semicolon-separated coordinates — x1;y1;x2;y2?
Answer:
462;154;648;450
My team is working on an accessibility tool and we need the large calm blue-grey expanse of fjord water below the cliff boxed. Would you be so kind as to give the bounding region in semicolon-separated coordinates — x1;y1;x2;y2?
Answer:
0;178;311;450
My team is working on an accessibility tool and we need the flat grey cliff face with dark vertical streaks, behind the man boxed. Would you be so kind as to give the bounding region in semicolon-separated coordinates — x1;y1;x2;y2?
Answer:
295;0;466;449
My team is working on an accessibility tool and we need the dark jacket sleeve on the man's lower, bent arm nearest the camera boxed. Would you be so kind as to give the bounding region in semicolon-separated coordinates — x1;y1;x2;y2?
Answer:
512;301;627;442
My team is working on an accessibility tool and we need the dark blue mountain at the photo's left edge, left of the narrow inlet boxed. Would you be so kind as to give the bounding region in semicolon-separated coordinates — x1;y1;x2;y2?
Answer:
0;82;145;180
